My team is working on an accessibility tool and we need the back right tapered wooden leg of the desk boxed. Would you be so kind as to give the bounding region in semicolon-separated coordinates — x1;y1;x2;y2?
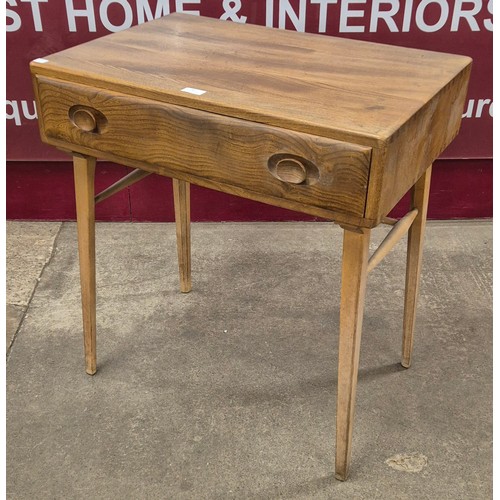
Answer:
401;167;432;368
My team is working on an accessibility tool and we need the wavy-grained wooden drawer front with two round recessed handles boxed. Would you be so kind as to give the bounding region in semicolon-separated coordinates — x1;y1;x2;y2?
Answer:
37;77;371;217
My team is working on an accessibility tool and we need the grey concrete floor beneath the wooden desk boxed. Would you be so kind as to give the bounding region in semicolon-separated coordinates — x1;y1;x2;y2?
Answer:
7;222;492;500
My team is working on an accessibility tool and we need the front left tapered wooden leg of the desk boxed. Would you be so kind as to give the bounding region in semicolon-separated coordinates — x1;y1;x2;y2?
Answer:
73;154;96;375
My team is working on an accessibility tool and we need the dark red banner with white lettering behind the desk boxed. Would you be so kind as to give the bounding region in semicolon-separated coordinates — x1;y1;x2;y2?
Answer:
6;0;493;160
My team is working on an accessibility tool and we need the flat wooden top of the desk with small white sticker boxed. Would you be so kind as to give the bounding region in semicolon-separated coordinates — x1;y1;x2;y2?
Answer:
32;14;471;147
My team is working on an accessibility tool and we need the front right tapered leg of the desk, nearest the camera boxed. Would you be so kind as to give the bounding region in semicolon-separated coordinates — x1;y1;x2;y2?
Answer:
335;229;370;481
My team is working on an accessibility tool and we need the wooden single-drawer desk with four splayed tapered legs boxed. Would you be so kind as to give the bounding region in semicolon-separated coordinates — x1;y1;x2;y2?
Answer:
31;14;471;480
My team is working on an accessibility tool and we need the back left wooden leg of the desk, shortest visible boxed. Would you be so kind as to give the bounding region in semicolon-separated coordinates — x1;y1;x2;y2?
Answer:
172;179;191;293
